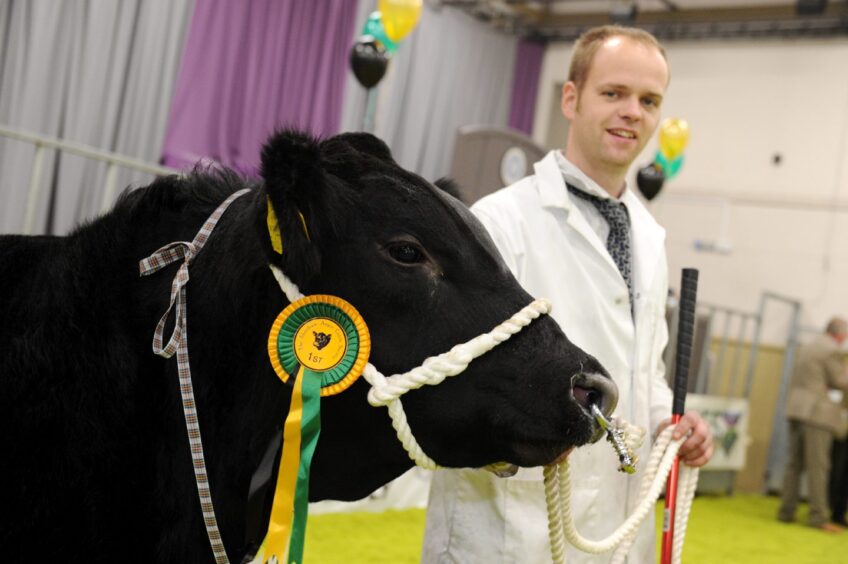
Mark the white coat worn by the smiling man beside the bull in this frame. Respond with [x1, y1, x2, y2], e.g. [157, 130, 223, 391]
[422, 152, 671, 564]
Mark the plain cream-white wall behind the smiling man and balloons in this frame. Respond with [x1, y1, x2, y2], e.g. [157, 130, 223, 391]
[533, 39, 848, 340]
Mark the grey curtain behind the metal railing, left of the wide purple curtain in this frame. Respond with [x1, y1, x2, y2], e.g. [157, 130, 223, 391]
[0, 0, 192, 234]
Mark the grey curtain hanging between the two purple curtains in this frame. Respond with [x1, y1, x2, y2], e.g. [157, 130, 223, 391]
[342, 4, 518, 185]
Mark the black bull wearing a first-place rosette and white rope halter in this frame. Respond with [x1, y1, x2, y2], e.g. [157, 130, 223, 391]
[0, 132, 616, 563]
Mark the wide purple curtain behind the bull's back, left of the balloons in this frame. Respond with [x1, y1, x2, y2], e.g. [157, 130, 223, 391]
[162, 0, 357, 174]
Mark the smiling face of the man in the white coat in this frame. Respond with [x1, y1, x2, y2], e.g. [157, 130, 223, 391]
[562, 37, 668, 187]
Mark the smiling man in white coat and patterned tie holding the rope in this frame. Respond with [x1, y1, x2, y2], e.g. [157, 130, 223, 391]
[422, 26, 713, 564]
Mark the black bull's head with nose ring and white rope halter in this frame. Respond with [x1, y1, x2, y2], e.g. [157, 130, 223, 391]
[256, 132, 617, 499]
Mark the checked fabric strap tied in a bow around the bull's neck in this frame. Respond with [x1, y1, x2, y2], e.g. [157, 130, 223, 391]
[138, 189, 250, 564]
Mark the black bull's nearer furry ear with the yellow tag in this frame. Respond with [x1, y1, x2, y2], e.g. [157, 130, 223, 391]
[256, 130, 327, 286]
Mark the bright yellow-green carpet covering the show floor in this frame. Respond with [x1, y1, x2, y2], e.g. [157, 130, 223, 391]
[304, 495, 848, 564]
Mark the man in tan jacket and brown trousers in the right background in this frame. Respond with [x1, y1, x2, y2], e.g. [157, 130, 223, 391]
[777, 317, 848, 533]
